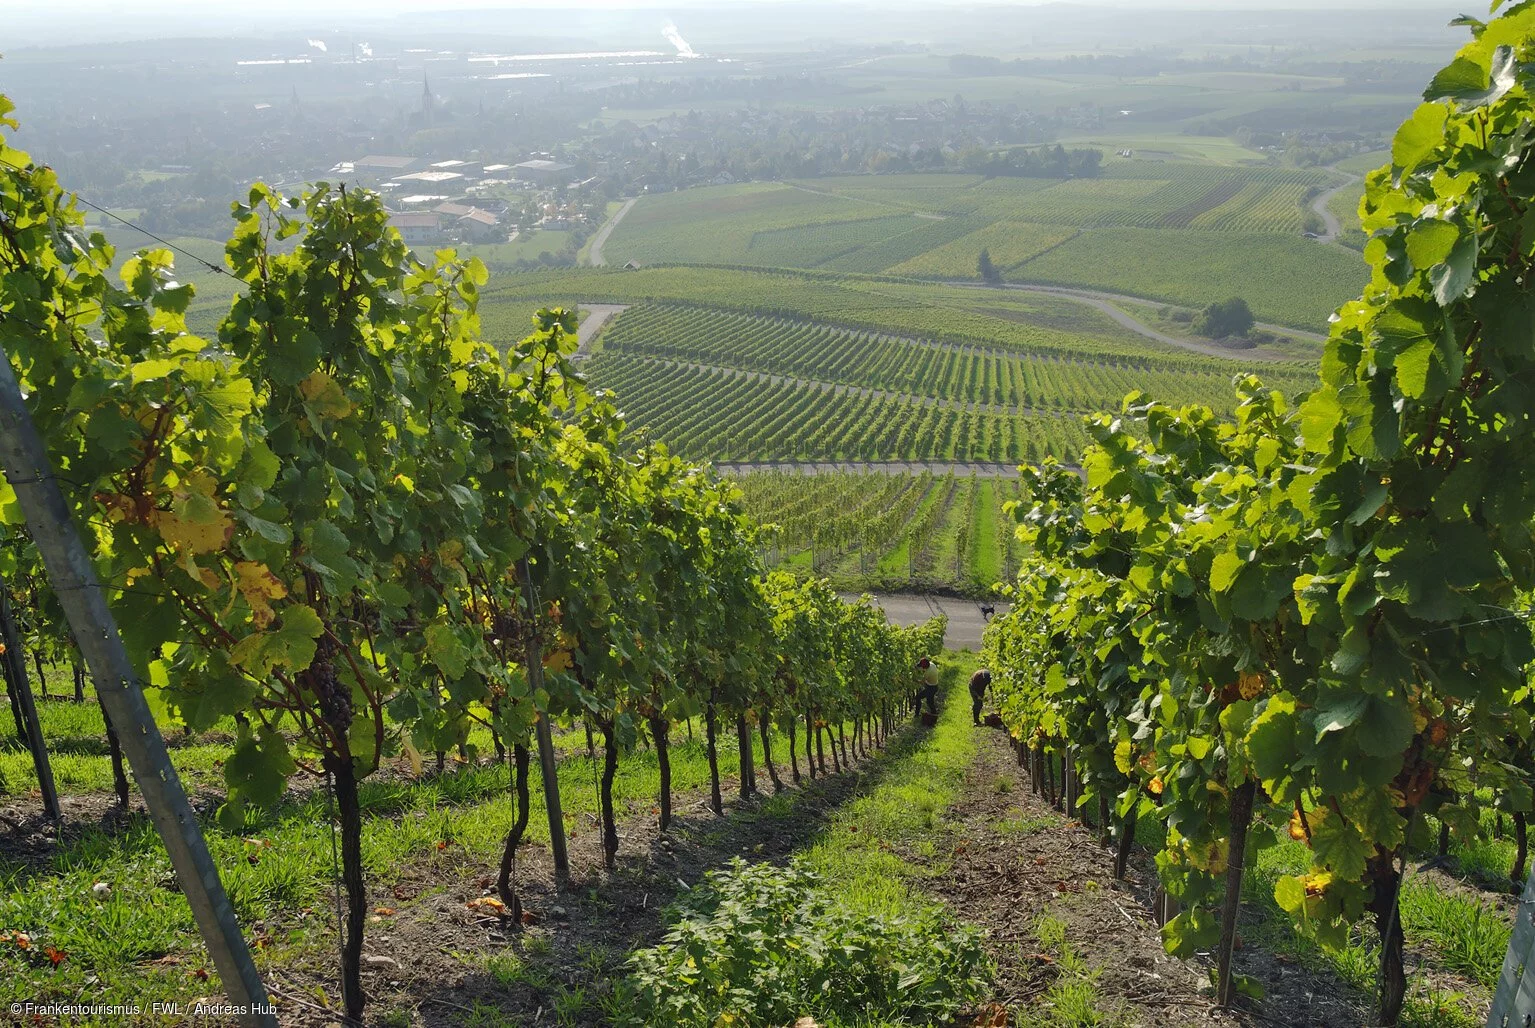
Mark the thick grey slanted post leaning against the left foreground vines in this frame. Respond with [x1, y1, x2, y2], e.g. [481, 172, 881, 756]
[0, 350, 278, 1028]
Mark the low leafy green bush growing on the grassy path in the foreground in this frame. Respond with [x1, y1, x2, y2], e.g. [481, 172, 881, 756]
[620, 859, 990, 1028]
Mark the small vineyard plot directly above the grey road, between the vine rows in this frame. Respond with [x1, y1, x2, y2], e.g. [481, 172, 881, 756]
[735, 471, 1021, 595]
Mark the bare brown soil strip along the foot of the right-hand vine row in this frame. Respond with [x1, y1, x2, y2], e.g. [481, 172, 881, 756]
[932, 729, 1369, 1028]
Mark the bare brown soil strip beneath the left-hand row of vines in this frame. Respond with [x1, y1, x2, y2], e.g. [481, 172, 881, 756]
[261, 727, 929, 1028]
